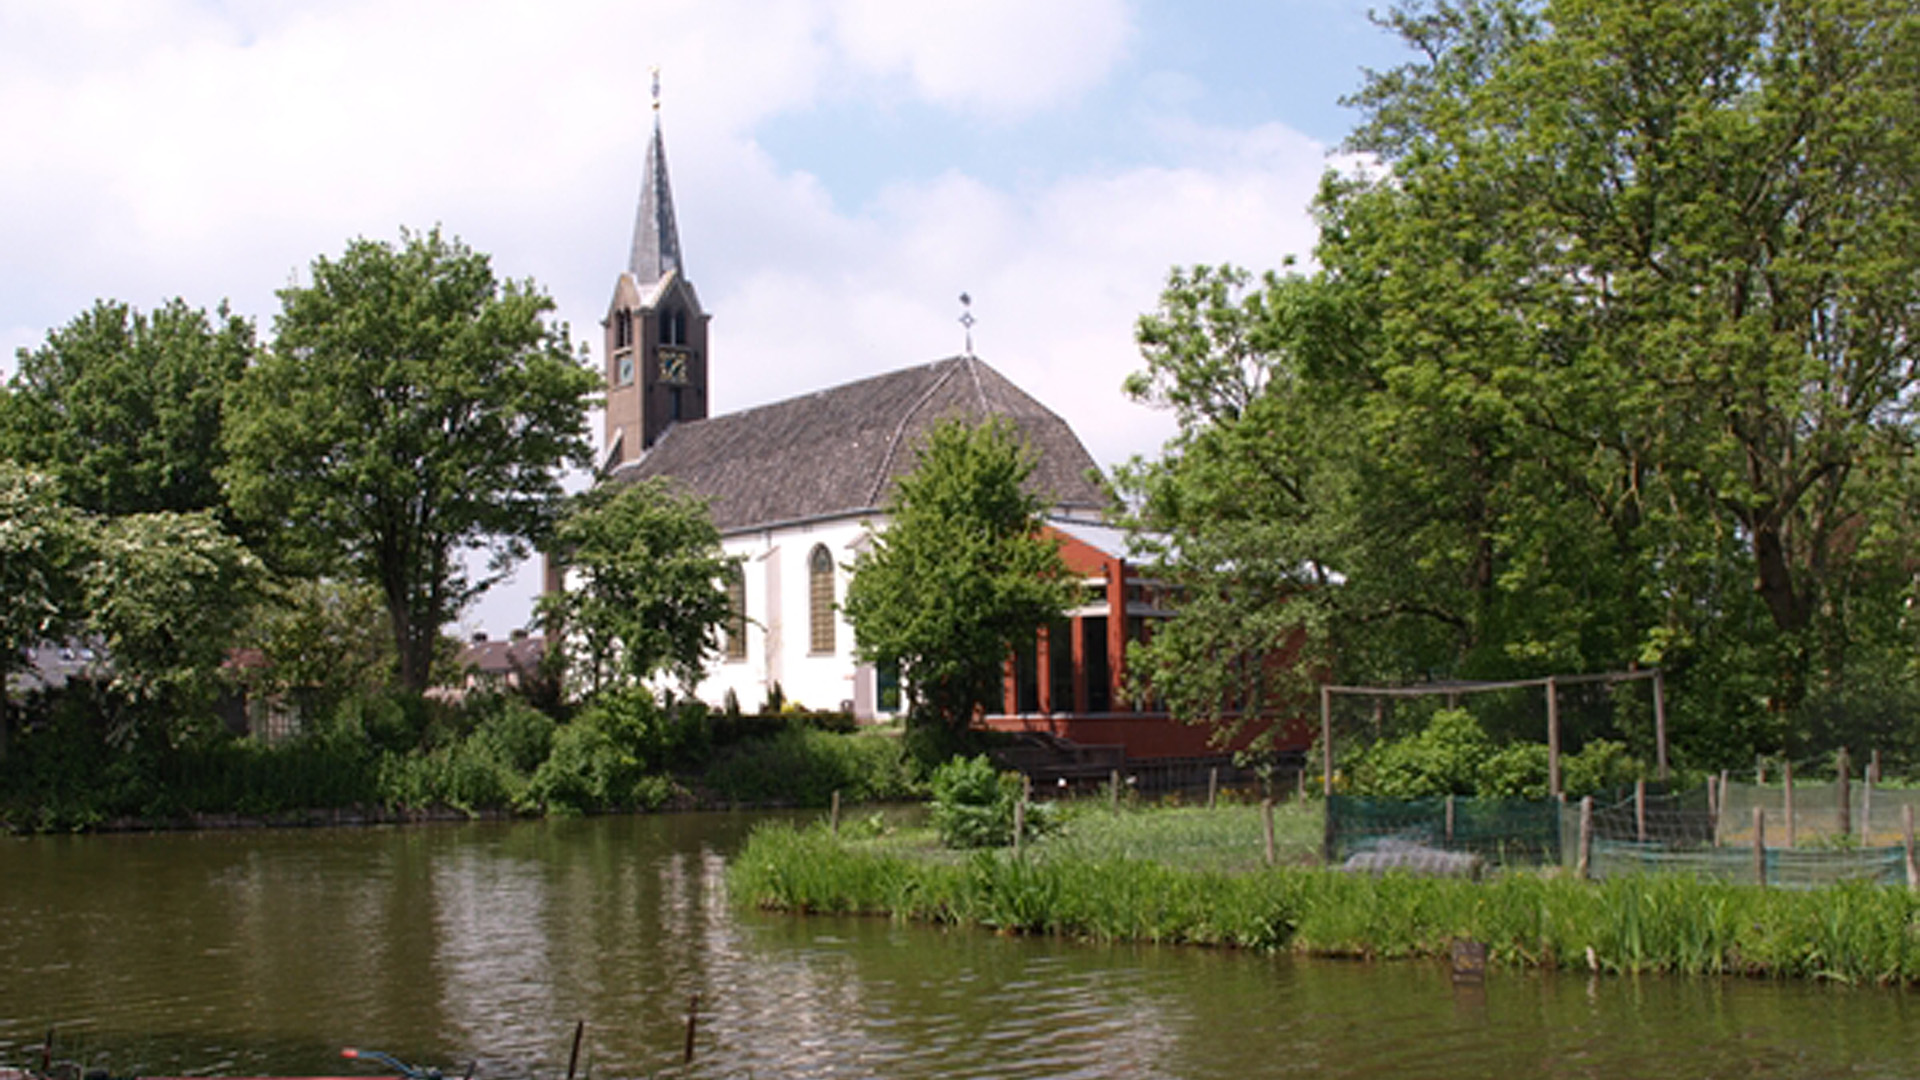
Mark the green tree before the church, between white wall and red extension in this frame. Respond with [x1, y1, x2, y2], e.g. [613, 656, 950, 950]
[845, 419, 1073, 730]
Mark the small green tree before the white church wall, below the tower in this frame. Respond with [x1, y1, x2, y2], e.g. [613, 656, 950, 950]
[541, 480, 735, 694]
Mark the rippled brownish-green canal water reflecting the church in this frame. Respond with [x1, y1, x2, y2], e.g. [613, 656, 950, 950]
[0, 815, 1920, 1080]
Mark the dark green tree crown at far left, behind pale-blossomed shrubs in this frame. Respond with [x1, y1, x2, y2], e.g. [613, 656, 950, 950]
[0, 300, 253, 515]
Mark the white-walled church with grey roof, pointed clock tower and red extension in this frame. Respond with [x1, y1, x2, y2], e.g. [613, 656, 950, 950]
[601, 98, 1267, 757]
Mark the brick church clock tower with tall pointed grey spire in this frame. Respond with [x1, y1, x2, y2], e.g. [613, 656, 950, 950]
[601, 73, 708, 471]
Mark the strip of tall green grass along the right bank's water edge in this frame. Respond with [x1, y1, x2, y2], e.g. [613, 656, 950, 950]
[732, 815, 1920, 984]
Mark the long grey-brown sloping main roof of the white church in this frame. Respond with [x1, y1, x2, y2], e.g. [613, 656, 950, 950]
[614, 356, 1108, 532]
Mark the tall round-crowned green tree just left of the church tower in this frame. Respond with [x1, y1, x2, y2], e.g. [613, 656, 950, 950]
[225, 229, 595, 692]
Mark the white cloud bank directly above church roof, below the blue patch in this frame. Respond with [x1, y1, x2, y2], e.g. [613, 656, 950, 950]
[706, 116, 1325, 465]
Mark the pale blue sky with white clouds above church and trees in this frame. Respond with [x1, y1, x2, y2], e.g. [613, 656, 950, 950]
[0, 0, 1407, 636]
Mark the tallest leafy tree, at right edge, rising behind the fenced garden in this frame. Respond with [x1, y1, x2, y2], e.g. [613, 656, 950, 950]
[1321, 0, 1920, 709]
